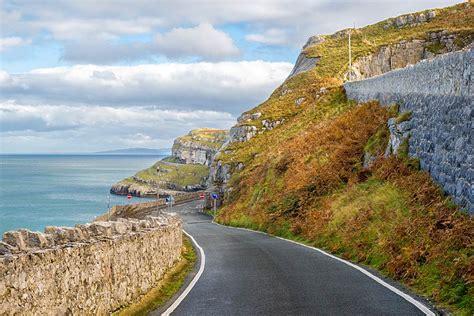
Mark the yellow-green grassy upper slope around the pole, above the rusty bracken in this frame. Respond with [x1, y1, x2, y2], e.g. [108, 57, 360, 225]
[220, 4, 474, 131]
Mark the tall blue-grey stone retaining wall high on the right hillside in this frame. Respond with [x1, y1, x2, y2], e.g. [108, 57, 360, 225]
[344, 47, 474, 214]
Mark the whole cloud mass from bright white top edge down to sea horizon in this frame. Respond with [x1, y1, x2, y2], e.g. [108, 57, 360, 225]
[0, 61, 292, 152]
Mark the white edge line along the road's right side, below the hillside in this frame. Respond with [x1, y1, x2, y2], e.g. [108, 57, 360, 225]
[212, 221, 436, 316]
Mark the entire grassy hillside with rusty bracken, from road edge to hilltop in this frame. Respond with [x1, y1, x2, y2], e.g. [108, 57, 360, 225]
[217, 4, 474, 315]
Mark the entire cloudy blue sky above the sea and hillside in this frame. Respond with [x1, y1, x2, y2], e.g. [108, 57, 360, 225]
[0, 0, 459, 153]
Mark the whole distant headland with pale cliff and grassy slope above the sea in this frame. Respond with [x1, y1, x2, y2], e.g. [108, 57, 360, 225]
[110, 128, 228, 197]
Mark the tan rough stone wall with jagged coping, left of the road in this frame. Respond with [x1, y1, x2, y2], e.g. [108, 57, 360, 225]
[0, 214, 182, 315]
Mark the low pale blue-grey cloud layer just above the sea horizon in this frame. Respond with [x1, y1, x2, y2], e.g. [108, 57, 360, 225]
[0, 101, 235, 152]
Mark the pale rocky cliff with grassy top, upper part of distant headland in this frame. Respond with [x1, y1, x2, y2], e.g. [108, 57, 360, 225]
[172, 128, 228, 166]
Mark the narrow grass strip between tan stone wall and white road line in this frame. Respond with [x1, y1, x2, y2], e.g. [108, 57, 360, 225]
[113, 235, 197, 316]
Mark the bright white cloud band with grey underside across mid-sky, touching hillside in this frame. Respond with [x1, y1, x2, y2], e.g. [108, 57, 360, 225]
[0, 61, 292, 114]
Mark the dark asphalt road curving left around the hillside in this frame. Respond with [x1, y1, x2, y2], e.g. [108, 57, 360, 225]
[159, 201, 434, 316]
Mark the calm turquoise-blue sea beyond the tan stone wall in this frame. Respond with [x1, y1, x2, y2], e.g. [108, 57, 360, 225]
[0, 155, 162, 234]
